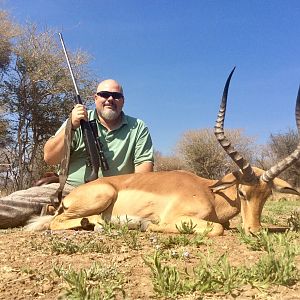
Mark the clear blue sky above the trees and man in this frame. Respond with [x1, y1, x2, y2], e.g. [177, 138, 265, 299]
[0, 0, 300, 154]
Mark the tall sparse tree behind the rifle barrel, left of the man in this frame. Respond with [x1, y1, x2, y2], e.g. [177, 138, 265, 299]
[0, 24, 96, 189]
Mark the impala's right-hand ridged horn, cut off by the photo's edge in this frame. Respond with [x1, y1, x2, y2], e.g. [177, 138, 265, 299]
[261, 86, 300, 182]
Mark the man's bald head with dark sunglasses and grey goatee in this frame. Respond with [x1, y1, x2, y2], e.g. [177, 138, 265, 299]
[94, 79, 124, 122]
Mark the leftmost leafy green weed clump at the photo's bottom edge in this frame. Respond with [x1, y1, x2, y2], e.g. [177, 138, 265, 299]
[54, 263, 125, 300]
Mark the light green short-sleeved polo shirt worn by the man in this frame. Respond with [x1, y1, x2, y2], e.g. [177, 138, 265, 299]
[56, 110, 154, 186]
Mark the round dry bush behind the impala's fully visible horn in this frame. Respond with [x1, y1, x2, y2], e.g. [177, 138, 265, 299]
[176, 129, 254, 179]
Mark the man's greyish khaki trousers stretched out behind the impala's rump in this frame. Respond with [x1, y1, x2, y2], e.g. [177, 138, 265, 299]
[0, 183, 75, 229]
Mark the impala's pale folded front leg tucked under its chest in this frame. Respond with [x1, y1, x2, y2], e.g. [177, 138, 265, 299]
[147, 217, 224, 236]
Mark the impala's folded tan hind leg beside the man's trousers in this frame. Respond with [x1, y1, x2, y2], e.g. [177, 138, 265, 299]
[50, 184, 117, 230]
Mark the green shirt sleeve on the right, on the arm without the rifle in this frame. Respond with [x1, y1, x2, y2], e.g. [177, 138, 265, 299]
[134, 121, 154, 166]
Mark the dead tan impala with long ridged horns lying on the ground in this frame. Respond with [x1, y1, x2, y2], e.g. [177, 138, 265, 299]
[26, 69, 300, 236]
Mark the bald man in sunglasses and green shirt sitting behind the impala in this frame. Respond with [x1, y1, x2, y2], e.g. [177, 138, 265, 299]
[0, 79, 153, 228]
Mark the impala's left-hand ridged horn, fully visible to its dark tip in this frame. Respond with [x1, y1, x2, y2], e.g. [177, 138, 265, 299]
[214, 67, 257, 183]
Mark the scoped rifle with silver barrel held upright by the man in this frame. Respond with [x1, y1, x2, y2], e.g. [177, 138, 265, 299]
[58, 33, 109, 182]
